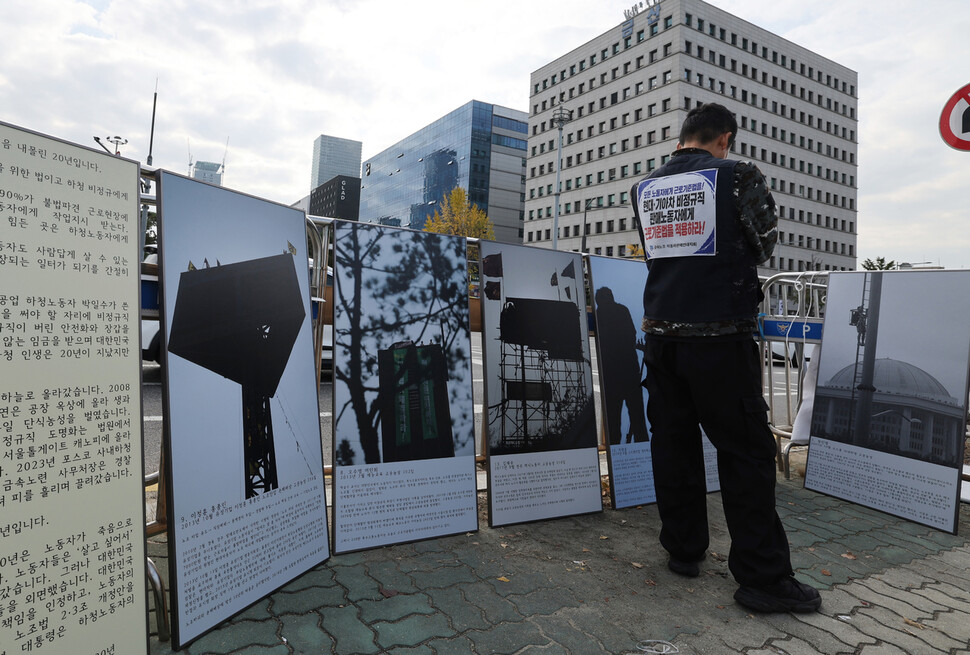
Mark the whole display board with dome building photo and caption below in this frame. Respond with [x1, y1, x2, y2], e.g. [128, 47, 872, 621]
[805, 271, 970, 533]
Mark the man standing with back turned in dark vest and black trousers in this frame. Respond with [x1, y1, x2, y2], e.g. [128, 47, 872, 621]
[633, 103, 822, 612]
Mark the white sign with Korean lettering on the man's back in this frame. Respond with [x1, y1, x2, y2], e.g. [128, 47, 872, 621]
[637, 168, 717, 259]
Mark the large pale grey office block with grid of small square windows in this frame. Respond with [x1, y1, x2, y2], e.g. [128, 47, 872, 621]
[525, 0, 858, 275]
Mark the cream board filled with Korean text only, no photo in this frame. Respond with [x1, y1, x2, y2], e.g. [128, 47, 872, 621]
[0, 123, 148, 655]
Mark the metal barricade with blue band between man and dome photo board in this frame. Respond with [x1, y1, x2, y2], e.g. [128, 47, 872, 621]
[759, 271, 828, 478]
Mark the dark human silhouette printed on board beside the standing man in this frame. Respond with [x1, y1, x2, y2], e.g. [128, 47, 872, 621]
[594, 286, 650, 444]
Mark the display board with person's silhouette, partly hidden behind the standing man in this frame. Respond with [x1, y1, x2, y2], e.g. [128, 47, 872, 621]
[589, 256, 720, 509]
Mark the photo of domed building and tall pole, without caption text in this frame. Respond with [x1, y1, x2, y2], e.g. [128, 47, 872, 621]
[811, 271, 970, 468]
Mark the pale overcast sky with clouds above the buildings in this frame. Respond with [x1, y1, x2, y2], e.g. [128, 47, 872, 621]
[0, 0, 970, 268]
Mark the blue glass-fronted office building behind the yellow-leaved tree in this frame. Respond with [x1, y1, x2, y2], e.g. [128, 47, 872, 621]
[360, 100, 528, 243]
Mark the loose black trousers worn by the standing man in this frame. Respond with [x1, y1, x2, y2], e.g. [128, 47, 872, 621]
[644, 336, 792, 586]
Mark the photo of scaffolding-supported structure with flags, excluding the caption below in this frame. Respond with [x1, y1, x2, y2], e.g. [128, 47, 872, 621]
[480, 242, 597, 456]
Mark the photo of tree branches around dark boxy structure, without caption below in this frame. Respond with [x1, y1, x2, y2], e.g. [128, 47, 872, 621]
[334, 222, 475, 466]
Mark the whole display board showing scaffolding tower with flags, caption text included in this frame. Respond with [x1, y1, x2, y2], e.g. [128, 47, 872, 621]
[479, 241, 603, 526]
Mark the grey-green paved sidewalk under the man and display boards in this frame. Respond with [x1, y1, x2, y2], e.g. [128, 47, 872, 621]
[149, 472, 970, 655]
